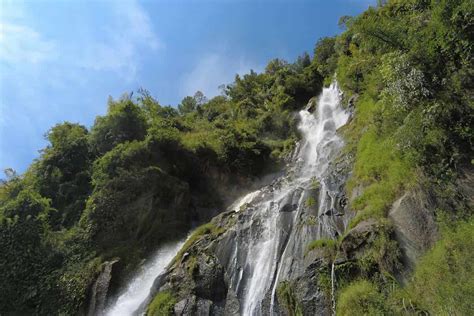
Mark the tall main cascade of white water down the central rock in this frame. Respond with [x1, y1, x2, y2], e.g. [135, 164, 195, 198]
[221, 83, 349, 315]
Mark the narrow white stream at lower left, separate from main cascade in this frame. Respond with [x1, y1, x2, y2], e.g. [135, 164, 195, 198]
[105, 239, 185, 316]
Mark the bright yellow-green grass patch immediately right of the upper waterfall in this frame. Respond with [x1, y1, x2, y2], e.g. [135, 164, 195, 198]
[347, 98, 415, 228]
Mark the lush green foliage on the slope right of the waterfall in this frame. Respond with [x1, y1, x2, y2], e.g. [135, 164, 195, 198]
[330, 0, 474, 315]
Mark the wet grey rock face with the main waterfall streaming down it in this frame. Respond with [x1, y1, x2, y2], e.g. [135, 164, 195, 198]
[146, 82, 353, 315]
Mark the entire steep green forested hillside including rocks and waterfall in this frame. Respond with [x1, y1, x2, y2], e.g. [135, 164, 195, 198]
[0, 0, 474, 315]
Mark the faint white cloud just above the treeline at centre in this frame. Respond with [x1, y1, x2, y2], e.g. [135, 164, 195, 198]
[181, 53, 263, 97]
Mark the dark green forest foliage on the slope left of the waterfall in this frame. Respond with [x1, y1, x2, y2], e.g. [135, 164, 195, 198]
[0, 49, 323, 314]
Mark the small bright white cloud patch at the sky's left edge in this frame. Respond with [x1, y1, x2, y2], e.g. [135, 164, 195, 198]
[0, 22, 56, 64]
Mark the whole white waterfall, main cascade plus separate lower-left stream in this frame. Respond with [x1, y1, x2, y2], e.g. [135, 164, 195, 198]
[124, 82, 352, 316]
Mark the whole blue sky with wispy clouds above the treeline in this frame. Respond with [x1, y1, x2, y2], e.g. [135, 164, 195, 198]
[0, 0, 375, 172]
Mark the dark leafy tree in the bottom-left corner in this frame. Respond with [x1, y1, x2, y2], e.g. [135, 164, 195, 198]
[0, 190, 61, 314]
